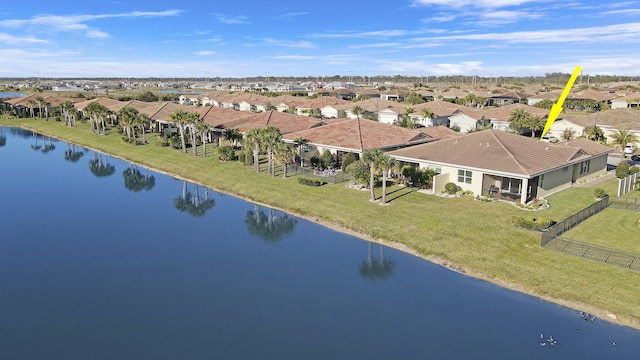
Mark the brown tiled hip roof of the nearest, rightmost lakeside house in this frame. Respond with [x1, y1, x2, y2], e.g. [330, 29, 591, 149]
[389, 130, 612, 178]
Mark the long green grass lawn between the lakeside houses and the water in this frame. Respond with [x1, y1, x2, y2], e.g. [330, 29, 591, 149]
[0, 114, 640, 327]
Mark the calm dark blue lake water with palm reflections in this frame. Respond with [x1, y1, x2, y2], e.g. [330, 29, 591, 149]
[0, 128, 640, 359]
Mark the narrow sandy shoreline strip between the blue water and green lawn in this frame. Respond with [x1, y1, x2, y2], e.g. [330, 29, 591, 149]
[12, 126, 640, 330]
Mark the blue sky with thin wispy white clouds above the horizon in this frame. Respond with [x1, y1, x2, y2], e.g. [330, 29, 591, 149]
[0, 0, 640, 77]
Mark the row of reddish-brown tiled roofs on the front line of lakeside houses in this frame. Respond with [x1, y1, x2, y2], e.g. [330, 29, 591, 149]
[2, 93, 616, 176]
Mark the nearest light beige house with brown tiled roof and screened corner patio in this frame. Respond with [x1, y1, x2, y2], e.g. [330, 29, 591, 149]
[389, 130, 612, 203]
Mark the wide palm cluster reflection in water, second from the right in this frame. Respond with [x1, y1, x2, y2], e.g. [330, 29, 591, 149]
[244, 205, 297, 242]
